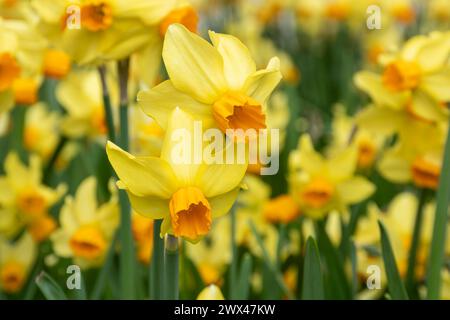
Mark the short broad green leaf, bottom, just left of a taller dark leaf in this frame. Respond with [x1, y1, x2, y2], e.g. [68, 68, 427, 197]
[302, 237, 325, 300]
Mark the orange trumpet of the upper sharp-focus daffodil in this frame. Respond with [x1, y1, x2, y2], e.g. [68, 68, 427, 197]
[213, 92, 266, 132]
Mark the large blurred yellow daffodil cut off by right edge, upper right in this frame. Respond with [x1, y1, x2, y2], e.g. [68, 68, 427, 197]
[355, 32, 450, 122]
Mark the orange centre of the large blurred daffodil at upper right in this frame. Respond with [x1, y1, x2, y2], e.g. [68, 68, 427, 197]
[382, 60, 422, 91]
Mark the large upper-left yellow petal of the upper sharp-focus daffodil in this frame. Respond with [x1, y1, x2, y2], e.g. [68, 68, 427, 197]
[163, 24, 226, 104]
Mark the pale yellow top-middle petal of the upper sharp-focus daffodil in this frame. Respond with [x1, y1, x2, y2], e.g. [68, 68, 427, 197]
[209, 31, 256, 90]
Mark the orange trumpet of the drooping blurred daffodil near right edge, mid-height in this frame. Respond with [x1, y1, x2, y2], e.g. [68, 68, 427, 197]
[411, 157, 441, 190]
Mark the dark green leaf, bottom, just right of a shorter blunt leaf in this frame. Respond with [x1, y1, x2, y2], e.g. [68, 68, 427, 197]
[317, 221, 352, 300]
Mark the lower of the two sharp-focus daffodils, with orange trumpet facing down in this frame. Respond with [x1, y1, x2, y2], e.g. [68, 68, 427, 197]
[106, 108, 247, 241]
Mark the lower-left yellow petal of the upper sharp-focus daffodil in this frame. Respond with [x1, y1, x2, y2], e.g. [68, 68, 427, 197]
[137, 80, 214, 129]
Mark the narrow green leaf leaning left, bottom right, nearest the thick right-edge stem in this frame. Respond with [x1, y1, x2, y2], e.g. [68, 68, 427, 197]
[378, 221, 408, 300]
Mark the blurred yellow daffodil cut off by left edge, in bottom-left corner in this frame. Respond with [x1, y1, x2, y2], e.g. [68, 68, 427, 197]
[0, 232, 37, 293]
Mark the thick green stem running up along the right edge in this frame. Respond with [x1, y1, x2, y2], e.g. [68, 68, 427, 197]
[427, 128, 450, 299]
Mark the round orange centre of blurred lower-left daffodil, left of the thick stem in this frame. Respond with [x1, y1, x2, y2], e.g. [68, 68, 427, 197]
[69, 226, 107, 260]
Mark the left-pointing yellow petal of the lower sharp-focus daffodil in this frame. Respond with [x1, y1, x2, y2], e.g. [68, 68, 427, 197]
[106, 142, 177, 199]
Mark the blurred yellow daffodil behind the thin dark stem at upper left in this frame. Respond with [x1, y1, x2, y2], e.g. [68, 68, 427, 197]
[56, 71, 118, 138]
